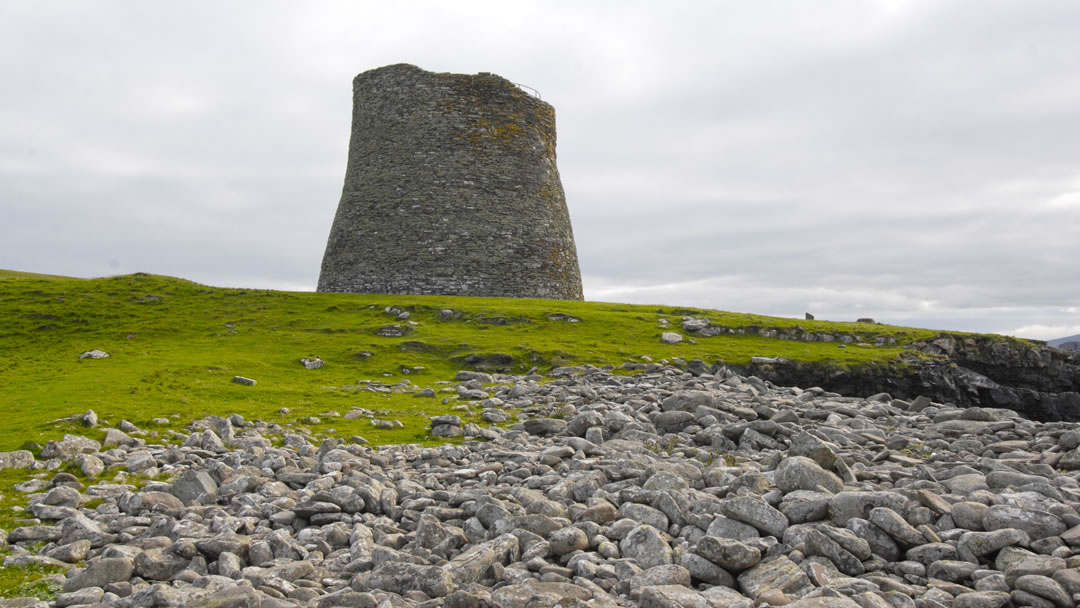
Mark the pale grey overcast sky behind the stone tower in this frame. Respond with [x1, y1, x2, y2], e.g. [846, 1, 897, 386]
[0, 0, 1080, 339]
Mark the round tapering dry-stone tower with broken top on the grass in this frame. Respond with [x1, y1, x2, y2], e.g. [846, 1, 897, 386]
[319, 64, 582, 299]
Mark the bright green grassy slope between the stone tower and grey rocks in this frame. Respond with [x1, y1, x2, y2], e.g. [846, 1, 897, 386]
[0, 271, 959, 450]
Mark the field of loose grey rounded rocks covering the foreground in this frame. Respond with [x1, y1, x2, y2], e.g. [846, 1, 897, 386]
[0, 364, 1080, 608]
